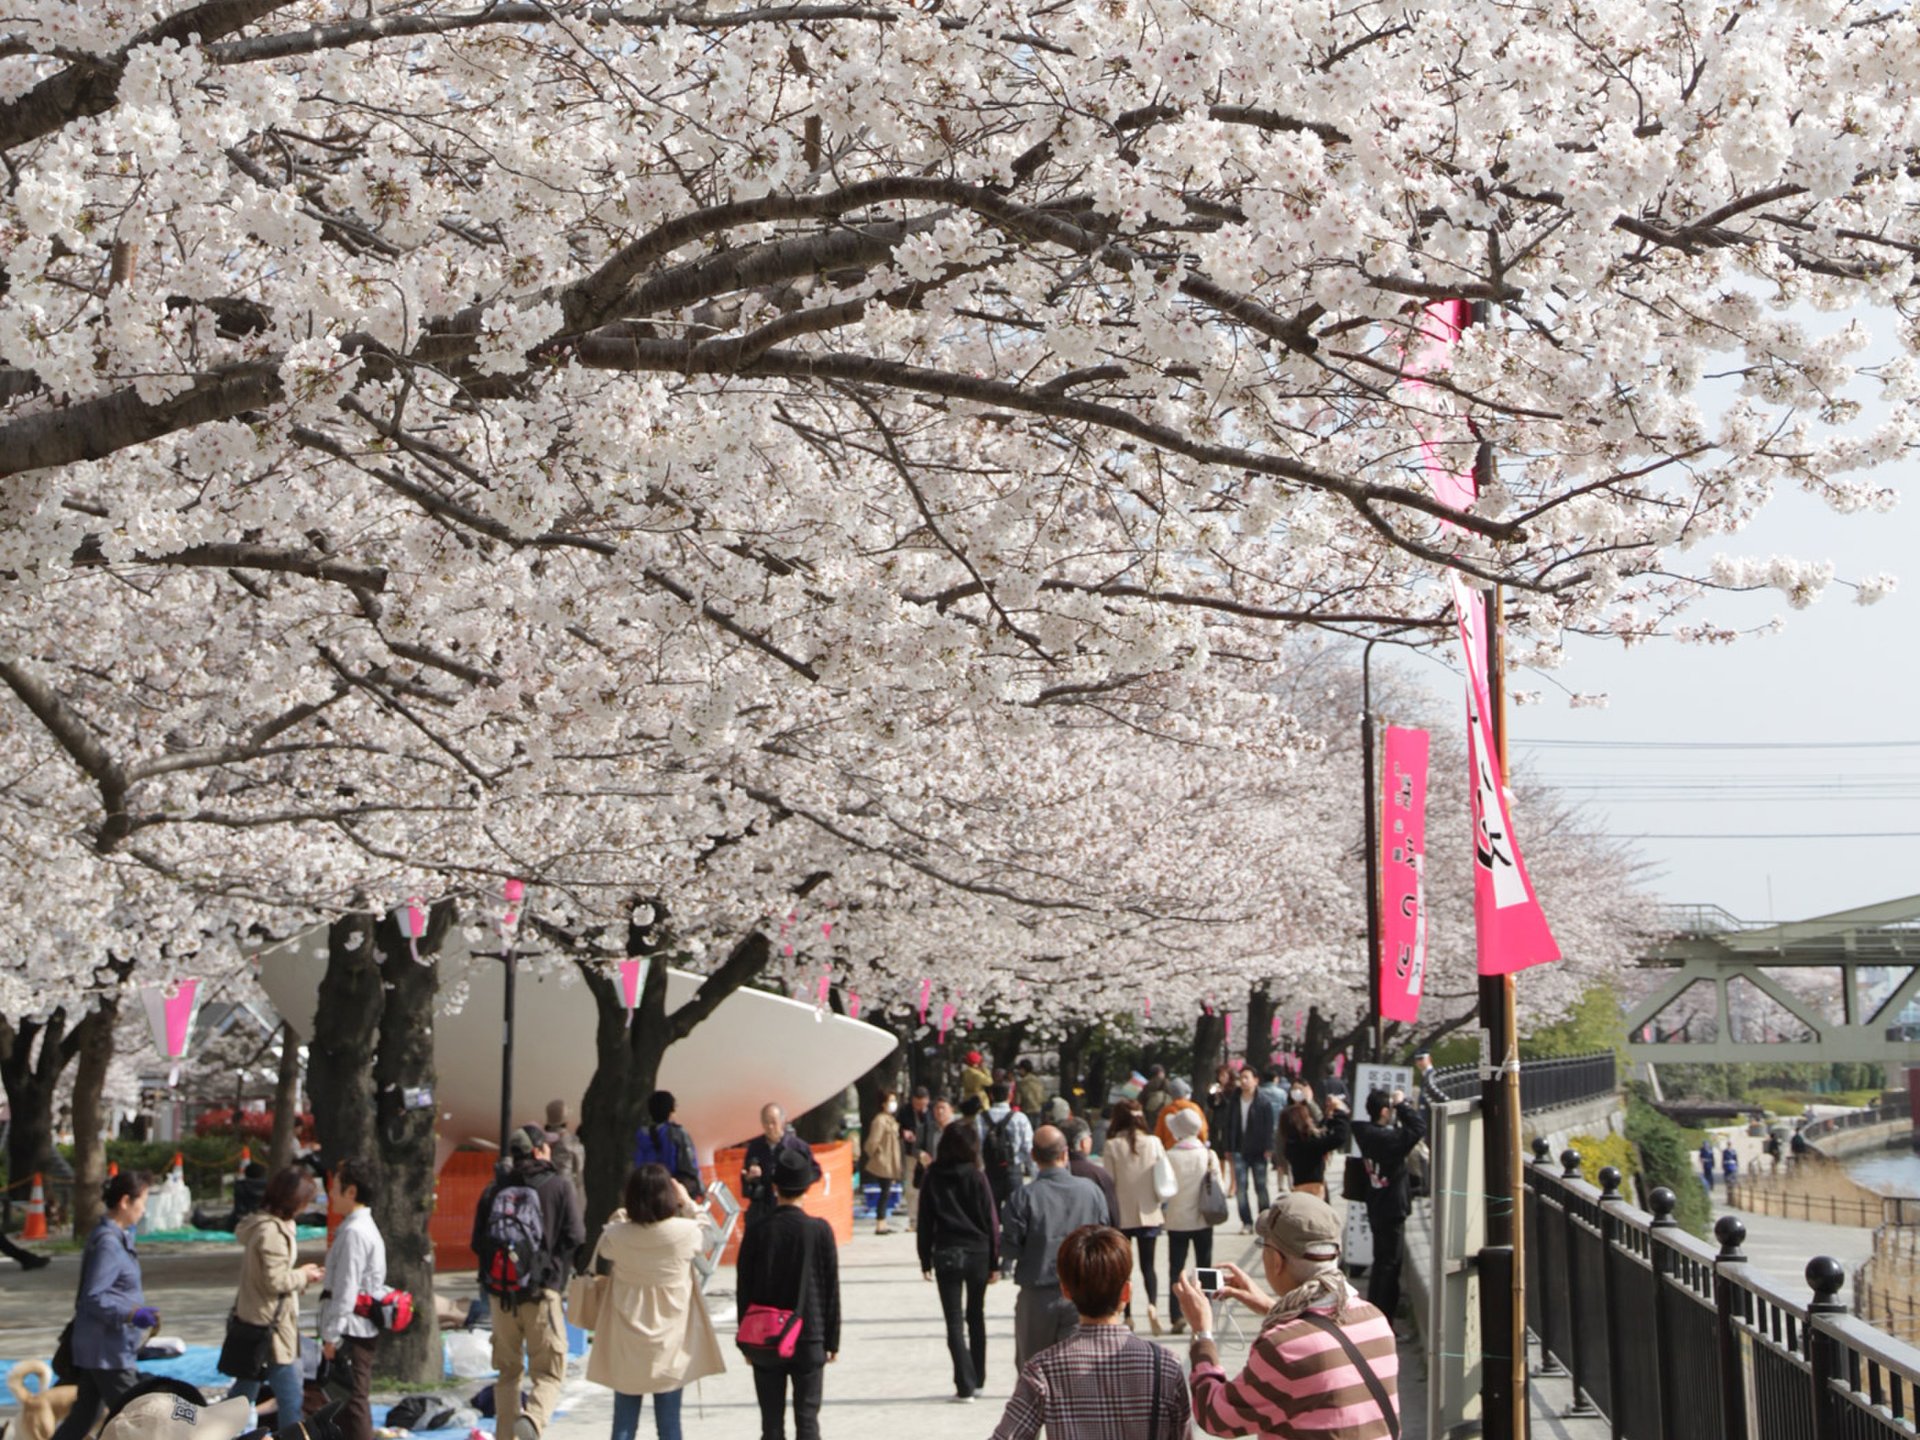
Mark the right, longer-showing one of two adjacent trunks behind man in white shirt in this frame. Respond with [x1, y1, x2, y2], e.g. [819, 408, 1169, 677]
[372, 900, 445, 1384]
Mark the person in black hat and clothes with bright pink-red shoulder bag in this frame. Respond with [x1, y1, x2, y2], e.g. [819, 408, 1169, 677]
[733, 1146, 839, 1440]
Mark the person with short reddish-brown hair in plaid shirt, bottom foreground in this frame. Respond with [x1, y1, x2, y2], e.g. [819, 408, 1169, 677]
[993, 1225, 1192, 1440]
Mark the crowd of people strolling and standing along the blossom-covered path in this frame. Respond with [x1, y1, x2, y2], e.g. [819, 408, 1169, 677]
[26, 1054, 1425, 1440]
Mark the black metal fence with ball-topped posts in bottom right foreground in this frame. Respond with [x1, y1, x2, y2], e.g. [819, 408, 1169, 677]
[1524, 1140, 1920, 1440]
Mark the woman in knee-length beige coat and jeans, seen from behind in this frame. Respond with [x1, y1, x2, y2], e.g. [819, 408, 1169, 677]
[588, 1165, 726, 1440]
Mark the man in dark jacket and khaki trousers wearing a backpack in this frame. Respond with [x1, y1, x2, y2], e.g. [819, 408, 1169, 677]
[472, 1125, 588, 1440]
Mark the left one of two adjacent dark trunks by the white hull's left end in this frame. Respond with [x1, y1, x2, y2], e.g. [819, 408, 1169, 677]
[307, 916, 384, 1169]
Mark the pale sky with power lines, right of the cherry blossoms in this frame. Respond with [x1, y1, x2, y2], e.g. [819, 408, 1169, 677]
[1402, 311, 1920, 920]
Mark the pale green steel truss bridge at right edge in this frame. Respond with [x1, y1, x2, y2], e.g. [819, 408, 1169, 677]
[1626, 895, 1920, 1069]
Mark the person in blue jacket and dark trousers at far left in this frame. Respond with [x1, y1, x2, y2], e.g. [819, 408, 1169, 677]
[54, 1171, 159, 1440]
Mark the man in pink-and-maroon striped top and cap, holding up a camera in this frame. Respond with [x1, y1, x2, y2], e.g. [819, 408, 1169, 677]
[1173, 1190, 1400, 1440]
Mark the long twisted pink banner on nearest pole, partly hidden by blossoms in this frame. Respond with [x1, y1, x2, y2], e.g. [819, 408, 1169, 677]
[1405, 300, 1561, 975]
